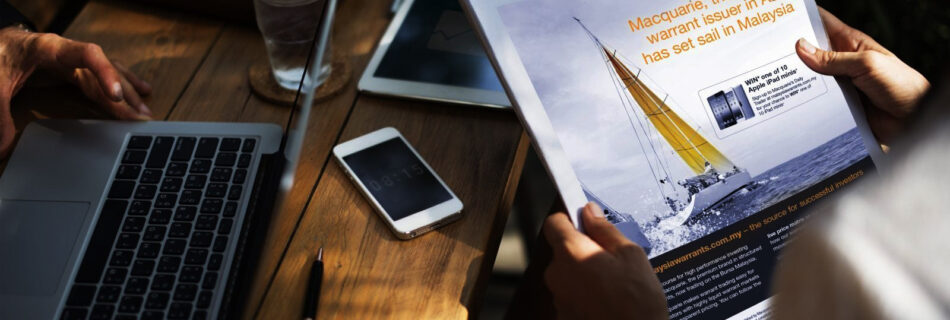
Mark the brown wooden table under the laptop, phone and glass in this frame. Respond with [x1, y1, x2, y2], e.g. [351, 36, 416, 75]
[5, 0, 528, 319]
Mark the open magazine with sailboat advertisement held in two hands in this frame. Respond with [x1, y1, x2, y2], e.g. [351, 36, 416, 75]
[462, 0, 881, 319]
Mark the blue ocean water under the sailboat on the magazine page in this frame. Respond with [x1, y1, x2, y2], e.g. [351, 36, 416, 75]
[643, 129, 868, 257]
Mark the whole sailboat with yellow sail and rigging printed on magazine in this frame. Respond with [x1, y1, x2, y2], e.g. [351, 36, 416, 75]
[574, 18, 753, 229]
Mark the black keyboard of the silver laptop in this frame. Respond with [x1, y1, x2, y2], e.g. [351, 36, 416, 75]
[62, 135, 257, 319]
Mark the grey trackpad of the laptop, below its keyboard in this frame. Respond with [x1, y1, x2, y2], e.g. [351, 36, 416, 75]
[0, 200, 89, 296]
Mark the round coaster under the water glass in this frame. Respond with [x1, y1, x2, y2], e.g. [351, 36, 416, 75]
[247, 52, 351, 106]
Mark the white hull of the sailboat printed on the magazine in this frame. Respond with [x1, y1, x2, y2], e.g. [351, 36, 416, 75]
[664, 170, 752, 226]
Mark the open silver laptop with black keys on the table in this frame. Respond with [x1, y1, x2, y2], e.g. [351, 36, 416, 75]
[0, 0, 336, 319]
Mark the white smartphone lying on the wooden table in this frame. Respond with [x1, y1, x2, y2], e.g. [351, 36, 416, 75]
[333, 128, 462, 240]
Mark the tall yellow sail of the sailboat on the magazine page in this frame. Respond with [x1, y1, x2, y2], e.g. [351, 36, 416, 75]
[603, 47, 734, 174]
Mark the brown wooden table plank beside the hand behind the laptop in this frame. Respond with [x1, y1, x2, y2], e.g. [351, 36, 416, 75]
[13, 1, 221, 129]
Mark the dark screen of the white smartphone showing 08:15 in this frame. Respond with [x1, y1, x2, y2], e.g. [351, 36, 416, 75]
[343, 137, 452, 221]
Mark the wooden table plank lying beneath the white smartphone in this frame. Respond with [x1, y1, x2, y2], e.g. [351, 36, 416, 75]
[258, 96, 527, 319]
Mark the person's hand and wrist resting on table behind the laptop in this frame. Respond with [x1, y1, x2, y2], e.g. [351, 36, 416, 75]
[0, 2, 152, 158]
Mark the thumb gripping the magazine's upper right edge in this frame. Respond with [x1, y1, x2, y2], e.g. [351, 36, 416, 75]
[795, 38, 881, 78]
